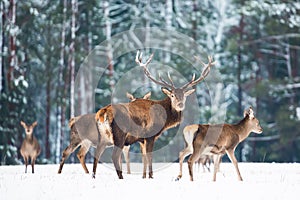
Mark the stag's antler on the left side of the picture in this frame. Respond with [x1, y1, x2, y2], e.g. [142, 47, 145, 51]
[135, 51, 174, 89]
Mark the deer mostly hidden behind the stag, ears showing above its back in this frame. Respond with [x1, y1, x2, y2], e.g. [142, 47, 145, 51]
[58, 92, 151, 174]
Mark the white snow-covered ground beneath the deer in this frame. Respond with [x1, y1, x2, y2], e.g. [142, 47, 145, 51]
[0, 163, 300, 200]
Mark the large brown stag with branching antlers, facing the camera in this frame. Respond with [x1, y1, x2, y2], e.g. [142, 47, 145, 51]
[93, 51, 214, 179]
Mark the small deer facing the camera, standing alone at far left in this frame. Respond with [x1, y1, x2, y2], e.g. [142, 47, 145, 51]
[20, 121, 41, 173]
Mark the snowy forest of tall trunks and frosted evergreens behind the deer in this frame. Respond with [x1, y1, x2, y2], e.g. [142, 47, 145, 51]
[0, 0, 300, 165]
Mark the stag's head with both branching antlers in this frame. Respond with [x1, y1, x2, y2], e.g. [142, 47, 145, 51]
[135, 51, 215, 112]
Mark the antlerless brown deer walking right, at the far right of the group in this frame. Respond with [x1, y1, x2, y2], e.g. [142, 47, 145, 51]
[178, 107, 263, 181]
